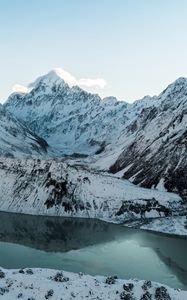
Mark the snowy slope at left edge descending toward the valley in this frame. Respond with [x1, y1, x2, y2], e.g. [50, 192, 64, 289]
[0, 106, 47, 157]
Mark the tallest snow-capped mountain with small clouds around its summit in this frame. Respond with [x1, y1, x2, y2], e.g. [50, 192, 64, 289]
[5, 70, 152, 154]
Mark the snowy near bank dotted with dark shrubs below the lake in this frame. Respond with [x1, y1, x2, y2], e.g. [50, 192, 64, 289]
[0, 269, 187, 300]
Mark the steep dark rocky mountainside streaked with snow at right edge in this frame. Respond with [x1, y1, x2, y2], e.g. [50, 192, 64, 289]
[110, 78, 187, 199]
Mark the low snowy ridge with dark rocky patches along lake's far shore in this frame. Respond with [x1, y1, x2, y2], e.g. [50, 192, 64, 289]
[0, 159, 186, 222]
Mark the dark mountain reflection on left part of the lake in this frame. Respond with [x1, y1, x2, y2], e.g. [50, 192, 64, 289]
[0, 212, 124, 252]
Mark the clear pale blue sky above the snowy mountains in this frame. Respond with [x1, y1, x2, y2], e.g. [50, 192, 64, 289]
[0, 0, 187, 102]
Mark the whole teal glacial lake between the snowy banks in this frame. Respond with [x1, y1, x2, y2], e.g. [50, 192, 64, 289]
[0, 212, 187, 289]
